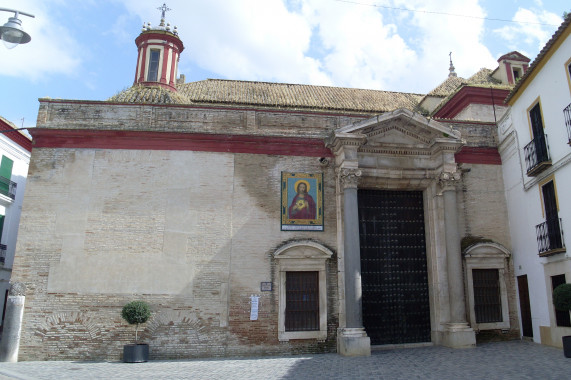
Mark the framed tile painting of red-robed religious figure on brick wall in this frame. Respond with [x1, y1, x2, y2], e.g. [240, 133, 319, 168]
[281, 172, 323, 231]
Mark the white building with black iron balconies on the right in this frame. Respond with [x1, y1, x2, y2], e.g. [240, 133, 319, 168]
[498, 17, 571, 347]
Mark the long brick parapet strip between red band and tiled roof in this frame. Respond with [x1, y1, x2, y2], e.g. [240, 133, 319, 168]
[37, 99, 368, 138]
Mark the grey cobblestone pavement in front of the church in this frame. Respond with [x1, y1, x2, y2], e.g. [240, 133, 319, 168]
[0, 341, 571, 380]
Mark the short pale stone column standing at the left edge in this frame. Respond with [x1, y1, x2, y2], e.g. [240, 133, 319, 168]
[0, 282, 26, 362]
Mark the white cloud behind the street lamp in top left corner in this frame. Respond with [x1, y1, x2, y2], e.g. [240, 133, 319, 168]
[0, 0, 81, 81]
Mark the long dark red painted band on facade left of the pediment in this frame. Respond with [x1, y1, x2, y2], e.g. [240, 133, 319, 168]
[31, 128, 333, 157]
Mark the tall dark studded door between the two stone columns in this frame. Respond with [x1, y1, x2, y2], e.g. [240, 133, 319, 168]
[358, 190, 430, 345]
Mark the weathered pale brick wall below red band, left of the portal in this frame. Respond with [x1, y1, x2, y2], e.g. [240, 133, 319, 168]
[13, 149, 338, 360]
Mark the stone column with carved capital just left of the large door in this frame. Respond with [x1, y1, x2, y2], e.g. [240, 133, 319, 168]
[338, 168, 371, 356]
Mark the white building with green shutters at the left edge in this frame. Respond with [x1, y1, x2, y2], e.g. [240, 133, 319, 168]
[0, 117, 32, 332]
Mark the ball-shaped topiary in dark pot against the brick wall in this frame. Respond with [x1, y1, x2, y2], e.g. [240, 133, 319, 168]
[121, 301, 151, 363]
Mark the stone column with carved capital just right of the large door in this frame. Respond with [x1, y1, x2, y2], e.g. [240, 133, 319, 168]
[438, 171, 476, 348]
